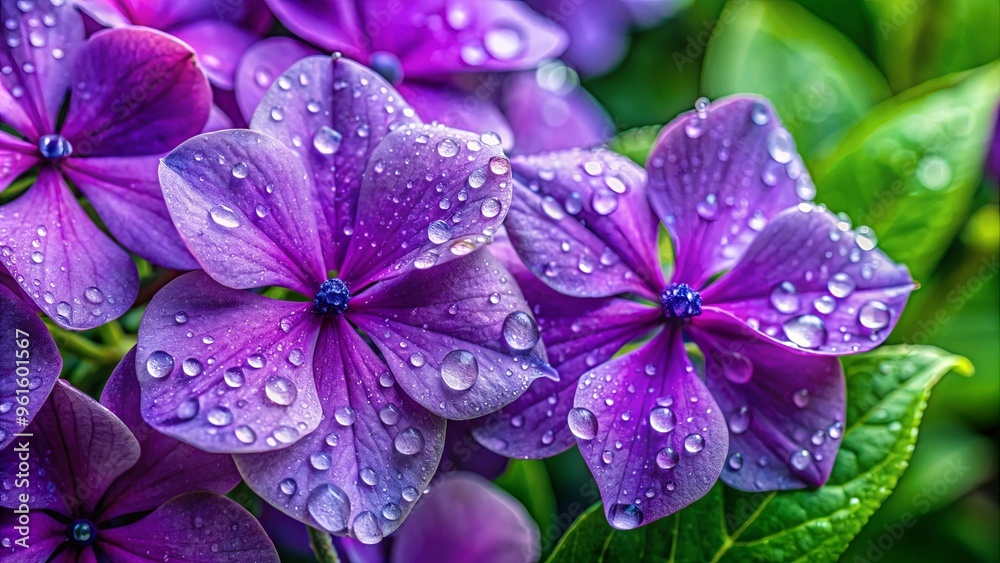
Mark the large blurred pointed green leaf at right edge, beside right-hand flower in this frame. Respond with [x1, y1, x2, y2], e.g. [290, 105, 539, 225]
[810, 63, 1000, 280]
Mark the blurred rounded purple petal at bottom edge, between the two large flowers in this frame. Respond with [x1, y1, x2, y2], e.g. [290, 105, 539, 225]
[391, 473, 541, 563]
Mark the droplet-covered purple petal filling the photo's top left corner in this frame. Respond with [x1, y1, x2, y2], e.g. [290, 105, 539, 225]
[0, 0, 83, 139]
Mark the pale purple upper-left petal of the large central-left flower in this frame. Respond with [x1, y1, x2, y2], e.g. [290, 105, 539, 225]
[160, 130, 326, 295]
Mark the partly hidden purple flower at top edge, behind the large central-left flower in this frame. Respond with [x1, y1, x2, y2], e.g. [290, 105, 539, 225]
[230, 0, 567, 148]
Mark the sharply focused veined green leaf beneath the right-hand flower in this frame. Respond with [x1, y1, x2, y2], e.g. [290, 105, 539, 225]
[548, 346, 972, 563]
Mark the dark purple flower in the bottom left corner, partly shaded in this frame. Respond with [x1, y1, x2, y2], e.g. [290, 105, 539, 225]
[0, 351, 277, 562]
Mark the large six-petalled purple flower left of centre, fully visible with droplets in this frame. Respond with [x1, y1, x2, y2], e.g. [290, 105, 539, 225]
[138, 56, 551, 543]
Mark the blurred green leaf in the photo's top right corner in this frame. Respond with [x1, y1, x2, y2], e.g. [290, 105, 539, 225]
[868, 0, 1000, 92]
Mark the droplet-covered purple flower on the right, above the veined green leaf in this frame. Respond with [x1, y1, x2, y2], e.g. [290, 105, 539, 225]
[476, 96, 914, 528]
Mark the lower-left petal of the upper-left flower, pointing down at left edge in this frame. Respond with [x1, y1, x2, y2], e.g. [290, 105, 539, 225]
[0, 167, 139, 330]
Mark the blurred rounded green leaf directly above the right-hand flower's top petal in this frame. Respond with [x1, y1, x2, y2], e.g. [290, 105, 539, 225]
[701, 0, 890, 155]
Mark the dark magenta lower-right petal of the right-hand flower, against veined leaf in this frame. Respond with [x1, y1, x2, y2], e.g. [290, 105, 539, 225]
[691, 308, 846, 491]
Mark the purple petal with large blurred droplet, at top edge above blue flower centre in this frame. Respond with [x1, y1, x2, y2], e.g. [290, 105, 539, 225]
[374, 0, 567, 78]
